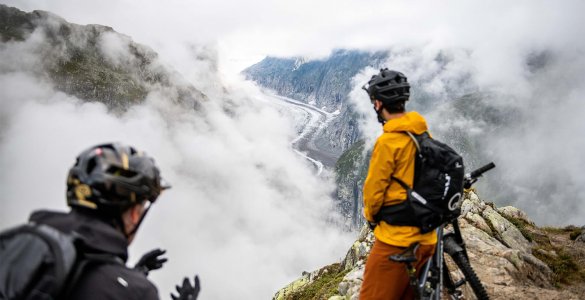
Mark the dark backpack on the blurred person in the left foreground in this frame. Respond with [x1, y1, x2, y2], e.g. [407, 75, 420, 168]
[0, 223, 123, 300]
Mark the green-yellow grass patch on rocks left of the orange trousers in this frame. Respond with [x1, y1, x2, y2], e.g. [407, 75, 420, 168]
[284, 263, 349, 300]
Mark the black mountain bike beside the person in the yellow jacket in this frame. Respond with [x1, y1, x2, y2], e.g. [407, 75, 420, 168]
[389, 163, 495, 300]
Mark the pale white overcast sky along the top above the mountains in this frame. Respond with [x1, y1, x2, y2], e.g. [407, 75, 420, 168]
[0, 0, 585, 71]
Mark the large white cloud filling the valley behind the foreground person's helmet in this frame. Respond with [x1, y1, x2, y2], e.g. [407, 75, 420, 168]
[0, 27, 352, 299]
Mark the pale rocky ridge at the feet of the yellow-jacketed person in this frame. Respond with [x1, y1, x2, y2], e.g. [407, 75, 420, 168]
[274, 191, 585, 300]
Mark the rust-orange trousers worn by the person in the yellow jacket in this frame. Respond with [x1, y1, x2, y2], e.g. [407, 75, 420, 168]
[360, 239, 435, 300]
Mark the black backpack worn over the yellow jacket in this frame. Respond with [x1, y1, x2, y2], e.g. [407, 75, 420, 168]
[375, 132, 465, 233]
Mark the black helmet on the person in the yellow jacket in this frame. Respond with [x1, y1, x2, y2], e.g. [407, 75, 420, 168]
[362, 68, 410, 105]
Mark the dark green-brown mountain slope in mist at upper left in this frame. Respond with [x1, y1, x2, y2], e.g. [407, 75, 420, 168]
[0, 5, 205, 112]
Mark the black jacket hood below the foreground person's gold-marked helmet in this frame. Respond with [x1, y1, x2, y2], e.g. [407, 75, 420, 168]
[29, 210, 128, 262]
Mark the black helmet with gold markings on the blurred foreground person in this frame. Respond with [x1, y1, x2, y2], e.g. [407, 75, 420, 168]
[67, 143, 169, 215]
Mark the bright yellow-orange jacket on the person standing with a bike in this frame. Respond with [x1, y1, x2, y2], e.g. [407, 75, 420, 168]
[364, 112, 437, 247]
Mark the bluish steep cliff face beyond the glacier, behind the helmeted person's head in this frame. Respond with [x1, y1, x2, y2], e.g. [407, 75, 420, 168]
[243, 50, 388, 156]
